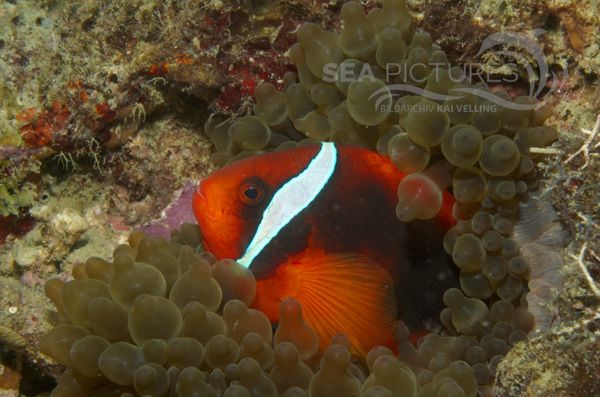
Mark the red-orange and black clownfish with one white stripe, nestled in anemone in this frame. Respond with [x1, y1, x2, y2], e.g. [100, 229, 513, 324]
[193, 142, 458, 355]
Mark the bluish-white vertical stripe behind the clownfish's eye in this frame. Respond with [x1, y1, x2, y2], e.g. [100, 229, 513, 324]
[237, 142, 337, 267]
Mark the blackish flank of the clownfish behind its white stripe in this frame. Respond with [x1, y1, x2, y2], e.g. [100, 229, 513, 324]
[244, 145, 459, 329]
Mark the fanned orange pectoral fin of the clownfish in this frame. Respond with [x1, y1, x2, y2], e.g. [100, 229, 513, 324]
[295, 254, 397, 356]
